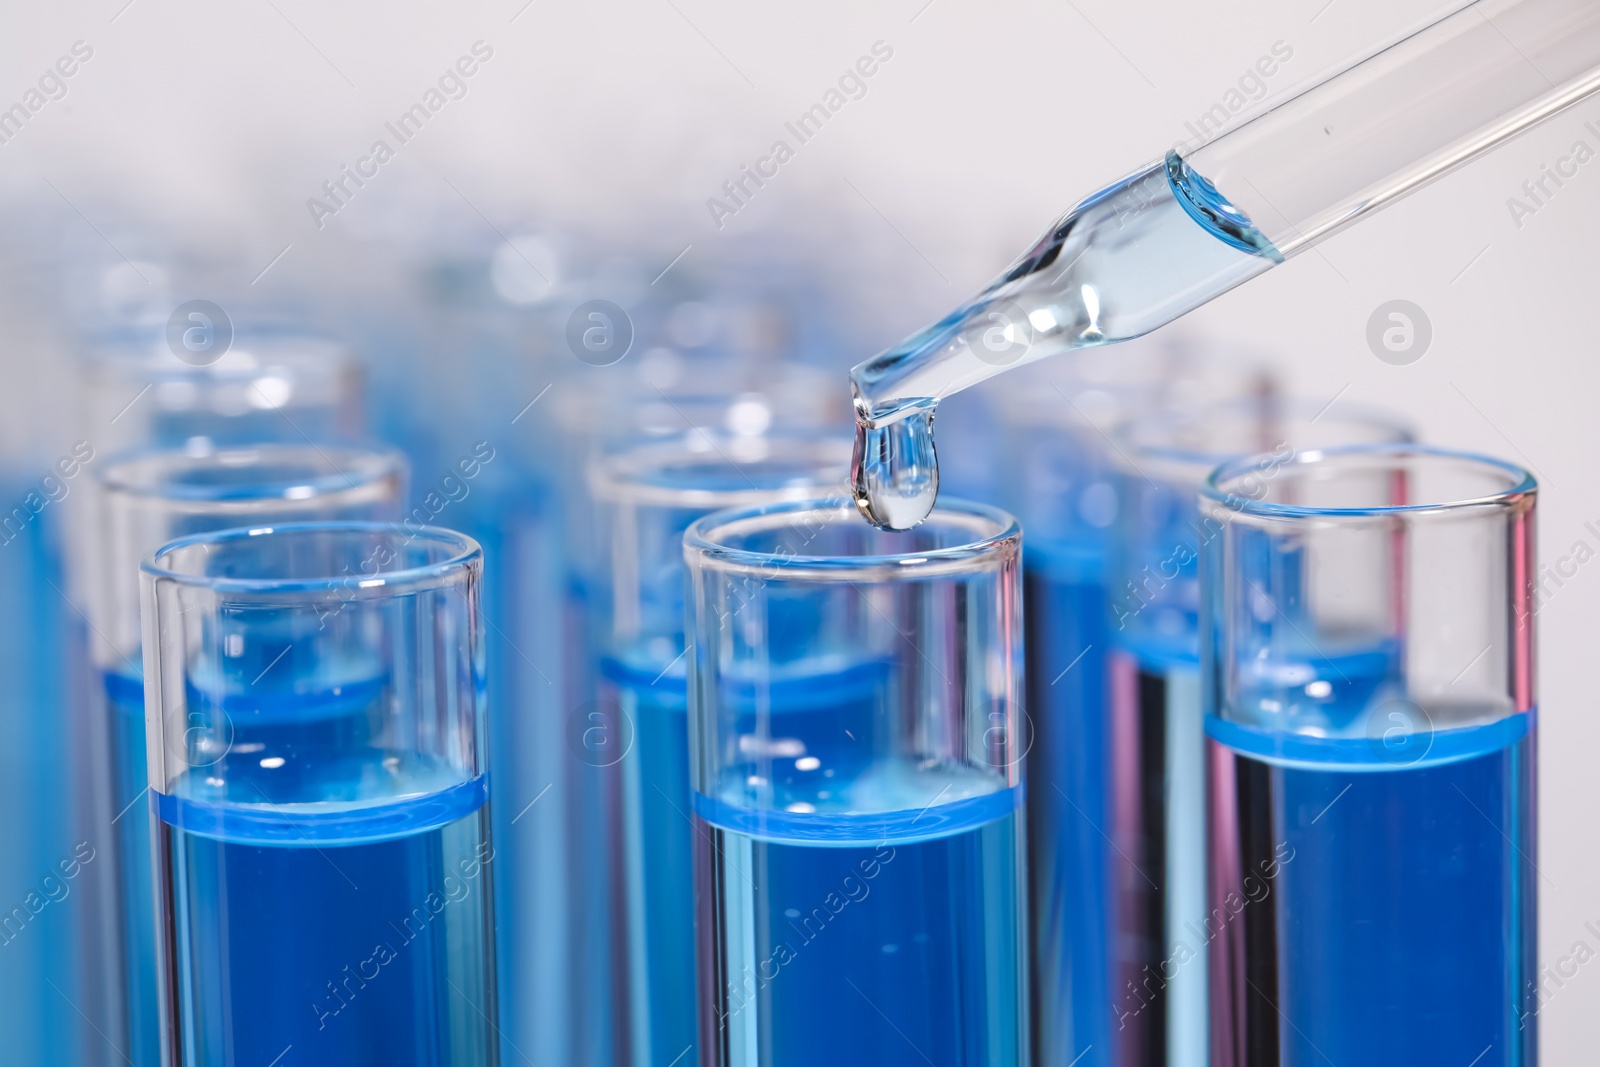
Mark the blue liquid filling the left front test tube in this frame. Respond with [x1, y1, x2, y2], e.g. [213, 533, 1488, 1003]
[152, 662, 499, 1067]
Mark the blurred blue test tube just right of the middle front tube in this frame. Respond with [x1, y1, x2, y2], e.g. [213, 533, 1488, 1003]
[985, 338, 1275, 1067]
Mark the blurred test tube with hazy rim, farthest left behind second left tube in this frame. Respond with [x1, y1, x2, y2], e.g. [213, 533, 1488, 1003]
[70, 334, 362, 1067]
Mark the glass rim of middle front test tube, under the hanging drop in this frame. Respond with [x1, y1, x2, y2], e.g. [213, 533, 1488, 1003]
[683, 498, 1022, 584]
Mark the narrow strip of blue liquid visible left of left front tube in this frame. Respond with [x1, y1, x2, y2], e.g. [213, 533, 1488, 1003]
[104, 672, 162, 1067]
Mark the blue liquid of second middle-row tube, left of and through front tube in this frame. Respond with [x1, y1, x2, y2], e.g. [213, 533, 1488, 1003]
[602, 656, 883, 1067]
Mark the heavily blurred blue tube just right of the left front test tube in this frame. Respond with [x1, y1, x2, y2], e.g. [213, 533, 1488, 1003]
[362, 299, 588, 1067]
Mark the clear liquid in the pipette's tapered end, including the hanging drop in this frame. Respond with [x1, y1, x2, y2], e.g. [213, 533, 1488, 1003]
[851, 154, 1282, 530]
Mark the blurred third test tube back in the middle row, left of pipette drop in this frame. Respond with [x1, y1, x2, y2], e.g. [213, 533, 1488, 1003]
[524, 369, 848, 1067]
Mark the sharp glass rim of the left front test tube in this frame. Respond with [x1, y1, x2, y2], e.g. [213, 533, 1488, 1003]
[139, 520, 483, 600]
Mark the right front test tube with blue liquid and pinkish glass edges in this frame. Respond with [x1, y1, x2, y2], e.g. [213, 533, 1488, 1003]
[1197, 445, 1539, 1067]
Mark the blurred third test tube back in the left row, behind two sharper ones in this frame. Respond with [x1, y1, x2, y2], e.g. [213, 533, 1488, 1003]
[62, 320, 380, 1062]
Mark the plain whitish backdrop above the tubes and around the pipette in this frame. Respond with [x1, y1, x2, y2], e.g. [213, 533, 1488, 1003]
[0, 0, 1600, 1067]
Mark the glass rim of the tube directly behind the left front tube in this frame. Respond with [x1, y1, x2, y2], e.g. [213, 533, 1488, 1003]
[96, 442, 408, 507]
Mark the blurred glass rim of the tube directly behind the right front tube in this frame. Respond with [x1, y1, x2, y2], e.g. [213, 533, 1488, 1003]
[1112, 395, 1416, 485]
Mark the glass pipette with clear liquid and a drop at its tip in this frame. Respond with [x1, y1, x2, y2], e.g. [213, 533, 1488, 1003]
[851, 0, 1600, 530]
